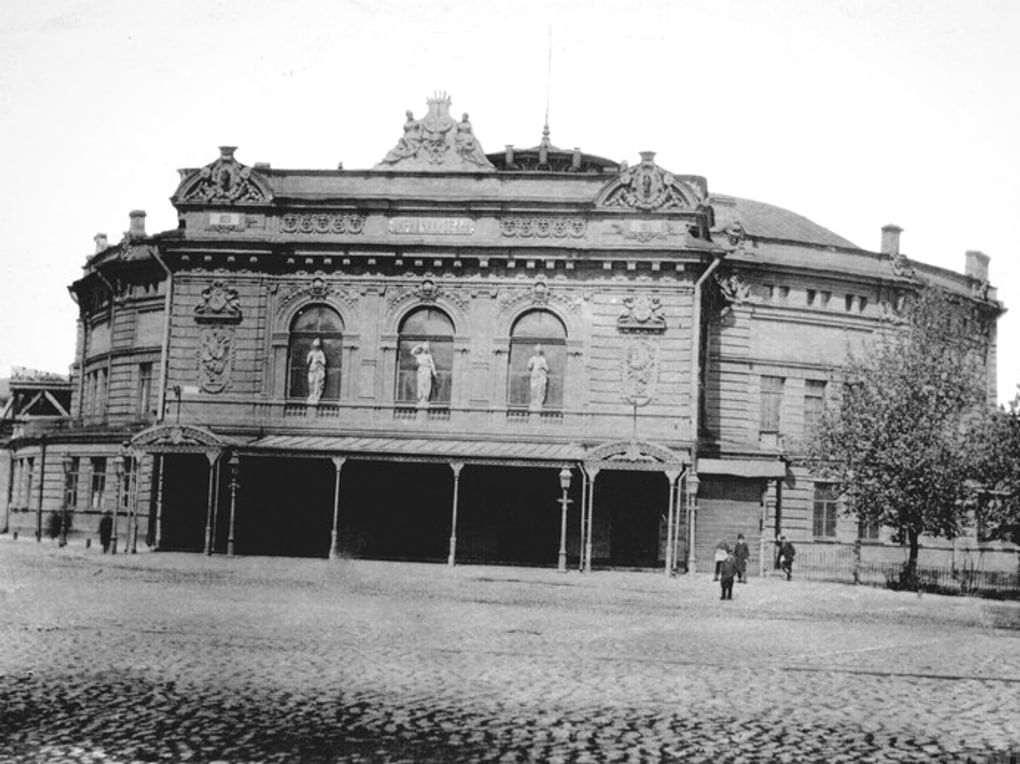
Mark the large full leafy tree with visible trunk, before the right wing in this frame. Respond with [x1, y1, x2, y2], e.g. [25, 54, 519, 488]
[807, 287, 987, 585]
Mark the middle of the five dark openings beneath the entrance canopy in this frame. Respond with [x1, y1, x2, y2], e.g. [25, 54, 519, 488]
[329, 459, 453, 561]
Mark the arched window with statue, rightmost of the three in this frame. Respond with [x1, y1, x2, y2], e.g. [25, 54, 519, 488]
[509, 310, 567, 410]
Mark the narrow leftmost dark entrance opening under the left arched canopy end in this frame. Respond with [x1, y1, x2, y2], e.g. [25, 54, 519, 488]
[159, 454, 209, 552]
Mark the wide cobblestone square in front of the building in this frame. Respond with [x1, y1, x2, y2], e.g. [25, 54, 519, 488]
[0, 541, 1020, 763]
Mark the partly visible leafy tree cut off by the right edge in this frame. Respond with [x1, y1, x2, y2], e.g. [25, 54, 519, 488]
[970, 386, 1020, 544]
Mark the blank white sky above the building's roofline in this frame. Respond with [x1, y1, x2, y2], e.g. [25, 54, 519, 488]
[0, 0, 1020, 401]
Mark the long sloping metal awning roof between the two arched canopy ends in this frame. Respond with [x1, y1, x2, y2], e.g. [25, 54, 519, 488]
[242, 436, 584, 467]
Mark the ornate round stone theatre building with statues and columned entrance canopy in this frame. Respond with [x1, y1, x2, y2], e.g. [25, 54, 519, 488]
[6, 94, 1001, 570]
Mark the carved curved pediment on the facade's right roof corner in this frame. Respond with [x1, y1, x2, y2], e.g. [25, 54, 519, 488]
[595, 151, 707, 212]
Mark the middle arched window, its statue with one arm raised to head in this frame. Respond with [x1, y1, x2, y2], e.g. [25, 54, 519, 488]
[397, 308, 453, 404]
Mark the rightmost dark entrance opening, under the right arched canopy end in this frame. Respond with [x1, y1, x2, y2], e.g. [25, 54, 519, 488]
[593, 470, 669, 567]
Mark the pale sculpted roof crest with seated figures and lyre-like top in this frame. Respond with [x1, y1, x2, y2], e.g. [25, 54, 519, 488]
[375, 93, 496, 172]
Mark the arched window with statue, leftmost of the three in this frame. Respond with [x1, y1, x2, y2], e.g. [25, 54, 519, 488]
[287, 305, 344, 403]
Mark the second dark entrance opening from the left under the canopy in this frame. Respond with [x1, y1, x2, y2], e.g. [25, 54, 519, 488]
[235, 457, 336, 557]
